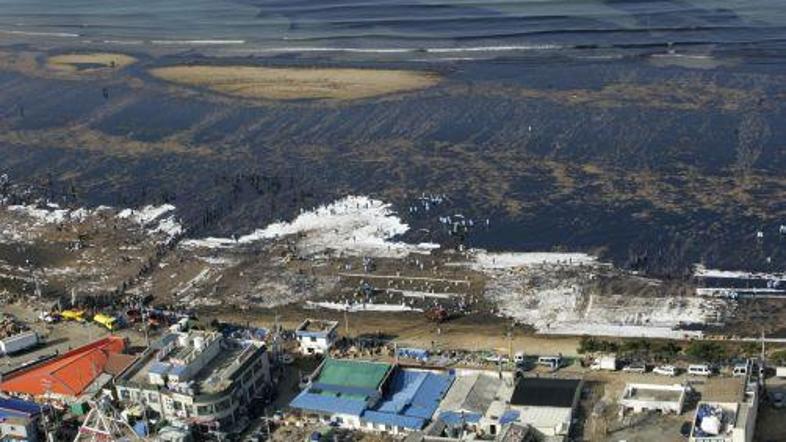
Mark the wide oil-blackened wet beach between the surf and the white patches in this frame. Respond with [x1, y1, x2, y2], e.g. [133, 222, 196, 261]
[0, 48, 786, 276]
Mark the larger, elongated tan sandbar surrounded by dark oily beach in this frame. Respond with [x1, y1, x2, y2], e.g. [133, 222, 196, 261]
[150, 66, 440, 100]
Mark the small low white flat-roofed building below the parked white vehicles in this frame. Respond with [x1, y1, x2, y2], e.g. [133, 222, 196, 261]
[620, 384, 687, 414]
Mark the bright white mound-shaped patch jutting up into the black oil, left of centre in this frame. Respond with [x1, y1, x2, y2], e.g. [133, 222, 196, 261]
[183, 196, 439, 258]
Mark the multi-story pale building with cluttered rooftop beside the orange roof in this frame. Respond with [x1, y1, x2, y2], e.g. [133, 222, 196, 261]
[115, 331, 270, 431]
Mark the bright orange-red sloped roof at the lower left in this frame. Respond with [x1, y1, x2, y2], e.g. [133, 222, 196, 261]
[0, 336, 126, 397]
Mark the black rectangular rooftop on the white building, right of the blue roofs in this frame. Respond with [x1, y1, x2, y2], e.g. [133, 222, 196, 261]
[510, 378, 581, 408]
